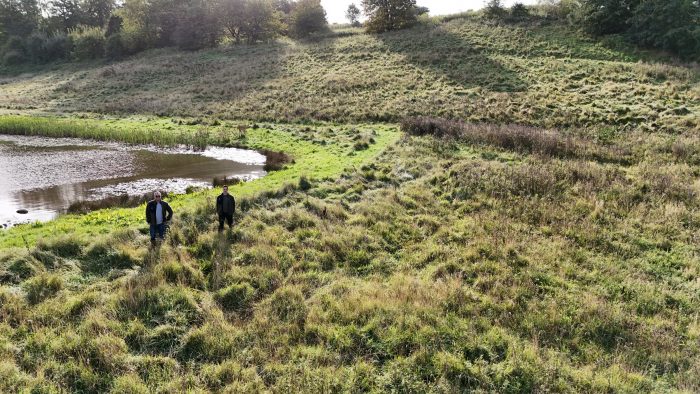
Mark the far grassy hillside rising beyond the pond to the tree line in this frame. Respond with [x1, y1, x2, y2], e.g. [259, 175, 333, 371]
[0, 19, 700, 132]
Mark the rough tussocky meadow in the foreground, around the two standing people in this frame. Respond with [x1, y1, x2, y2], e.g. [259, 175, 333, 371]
[0, 118, 700, 392]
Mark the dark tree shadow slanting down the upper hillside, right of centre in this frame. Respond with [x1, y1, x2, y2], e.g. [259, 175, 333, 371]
[378, 26, 528, 92]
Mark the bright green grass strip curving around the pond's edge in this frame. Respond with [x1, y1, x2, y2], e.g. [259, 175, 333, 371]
[0, 116, 400, 249]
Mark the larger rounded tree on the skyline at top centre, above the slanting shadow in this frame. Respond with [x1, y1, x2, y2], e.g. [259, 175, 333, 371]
[362, 0, 416, 33]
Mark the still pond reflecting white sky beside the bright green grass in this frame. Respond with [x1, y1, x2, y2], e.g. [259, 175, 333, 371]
[0, 134, 265, 229]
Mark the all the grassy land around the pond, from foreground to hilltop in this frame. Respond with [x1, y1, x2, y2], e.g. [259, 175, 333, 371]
[0, 14, 700, 393]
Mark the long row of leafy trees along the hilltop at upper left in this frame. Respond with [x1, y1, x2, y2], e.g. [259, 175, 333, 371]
[0, 0, 328, 64]
